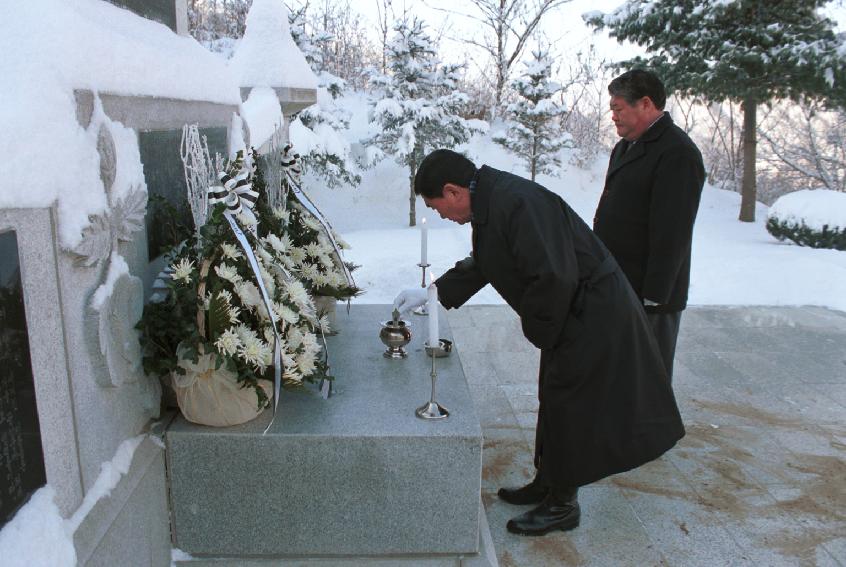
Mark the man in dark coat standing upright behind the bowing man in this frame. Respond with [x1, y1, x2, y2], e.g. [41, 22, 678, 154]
[593, 69, 705, 379]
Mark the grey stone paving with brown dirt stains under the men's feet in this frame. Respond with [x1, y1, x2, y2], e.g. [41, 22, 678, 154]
[449, 306, 846, 567]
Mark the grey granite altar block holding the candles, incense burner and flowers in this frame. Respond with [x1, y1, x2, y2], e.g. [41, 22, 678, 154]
[166, 305, 496, 567]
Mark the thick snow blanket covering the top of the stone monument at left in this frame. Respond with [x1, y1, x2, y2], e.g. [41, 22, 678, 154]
[0, 0, 234, 248]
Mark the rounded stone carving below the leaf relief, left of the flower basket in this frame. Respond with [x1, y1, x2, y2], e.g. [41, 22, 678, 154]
[98, 274, 144, 386]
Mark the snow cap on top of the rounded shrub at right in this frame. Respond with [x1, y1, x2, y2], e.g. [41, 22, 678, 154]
[767, 189, 846, 231]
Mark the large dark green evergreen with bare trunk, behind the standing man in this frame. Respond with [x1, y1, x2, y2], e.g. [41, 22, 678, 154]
[585, 0, 846, 222]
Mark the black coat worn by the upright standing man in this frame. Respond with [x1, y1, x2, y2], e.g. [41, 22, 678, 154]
[593, 113, 705, 313]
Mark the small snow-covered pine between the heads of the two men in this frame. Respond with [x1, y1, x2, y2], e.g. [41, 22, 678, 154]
[494, 48, 572, 181]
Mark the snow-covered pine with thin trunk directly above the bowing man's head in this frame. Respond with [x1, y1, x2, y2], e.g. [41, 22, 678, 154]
[363, 17, 478, 226]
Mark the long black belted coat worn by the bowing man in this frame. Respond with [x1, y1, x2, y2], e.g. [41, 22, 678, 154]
[437, 166, 684, 487]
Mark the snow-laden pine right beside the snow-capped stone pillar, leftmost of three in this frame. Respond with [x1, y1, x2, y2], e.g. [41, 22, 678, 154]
[288, 6, 361, 187]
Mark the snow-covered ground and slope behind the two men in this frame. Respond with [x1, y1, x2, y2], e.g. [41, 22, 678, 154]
[304, 93, 846, 311]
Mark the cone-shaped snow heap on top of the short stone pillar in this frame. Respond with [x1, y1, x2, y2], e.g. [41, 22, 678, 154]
[229, 0, 317, 89]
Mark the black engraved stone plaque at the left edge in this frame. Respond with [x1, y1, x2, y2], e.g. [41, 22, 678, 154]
[0, 231, 47, 526]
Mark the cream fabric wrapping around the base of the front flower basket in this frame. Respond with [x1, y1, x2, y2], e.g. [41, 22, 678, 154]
[172, 354, 273, 427]
